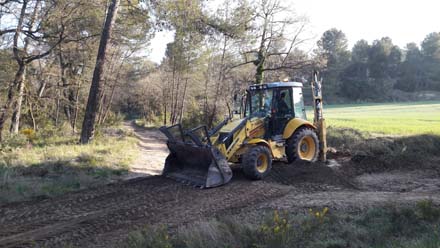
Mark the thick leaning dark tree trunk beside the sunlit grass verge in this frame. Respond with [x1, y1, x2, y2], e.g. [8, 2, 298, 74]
[80, 0, 120, 144]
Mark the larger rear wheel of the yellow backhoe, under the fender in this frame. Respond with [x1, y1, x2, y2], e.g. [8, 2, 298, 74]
[286, 127, 319, 163]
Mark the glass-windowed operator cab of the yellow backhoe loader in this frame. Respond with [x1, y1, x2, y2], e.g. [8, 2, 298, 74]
[244, 82, 306, 138]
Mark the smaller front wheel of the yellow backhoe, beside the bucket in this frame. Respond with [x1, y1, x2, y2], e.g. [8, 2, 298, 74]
[242, 145, 272, 180]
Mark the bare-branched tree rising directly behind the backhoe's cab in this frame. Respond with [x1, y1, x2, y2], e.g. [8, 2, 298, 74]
[235, 0, 311, 84]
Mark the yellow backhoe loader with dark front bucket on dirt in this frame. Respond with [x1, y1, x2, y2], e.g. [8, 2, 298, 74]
[160, 72, 326, 188]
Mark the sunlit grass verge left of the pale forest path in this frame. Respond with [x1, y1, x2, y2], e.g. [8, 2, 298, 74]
[0, 127, 138, 204]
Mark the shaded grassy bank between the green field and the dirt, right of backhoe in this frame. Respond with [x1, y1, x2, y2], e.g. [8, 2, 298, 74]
[327, 128, 440, 174]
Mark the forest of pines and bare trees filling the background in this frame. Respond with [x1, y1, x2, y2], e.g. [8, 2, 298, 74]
[0, 0, 440, 140]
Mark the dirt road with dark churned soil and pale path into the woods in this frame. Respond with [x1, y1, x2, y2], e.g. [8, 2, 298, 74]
[0, 125, 440, 247]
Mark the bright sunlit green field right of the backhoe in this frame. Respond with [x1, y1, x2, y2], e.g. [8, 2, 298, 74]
[308, 101, 440, 135]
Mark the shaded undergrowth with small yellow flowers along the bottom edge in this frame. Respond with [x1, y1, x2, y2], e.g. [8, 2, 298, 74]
[121, 200, 440, 248]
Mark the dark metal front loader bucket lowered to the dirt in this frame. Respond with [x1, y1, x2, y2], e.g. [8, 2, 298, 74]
[160, 125, 232, 188]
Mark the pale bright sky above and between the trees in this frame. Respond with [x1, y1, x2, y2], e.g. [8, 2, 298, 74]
[149, 0, 440, 63]
